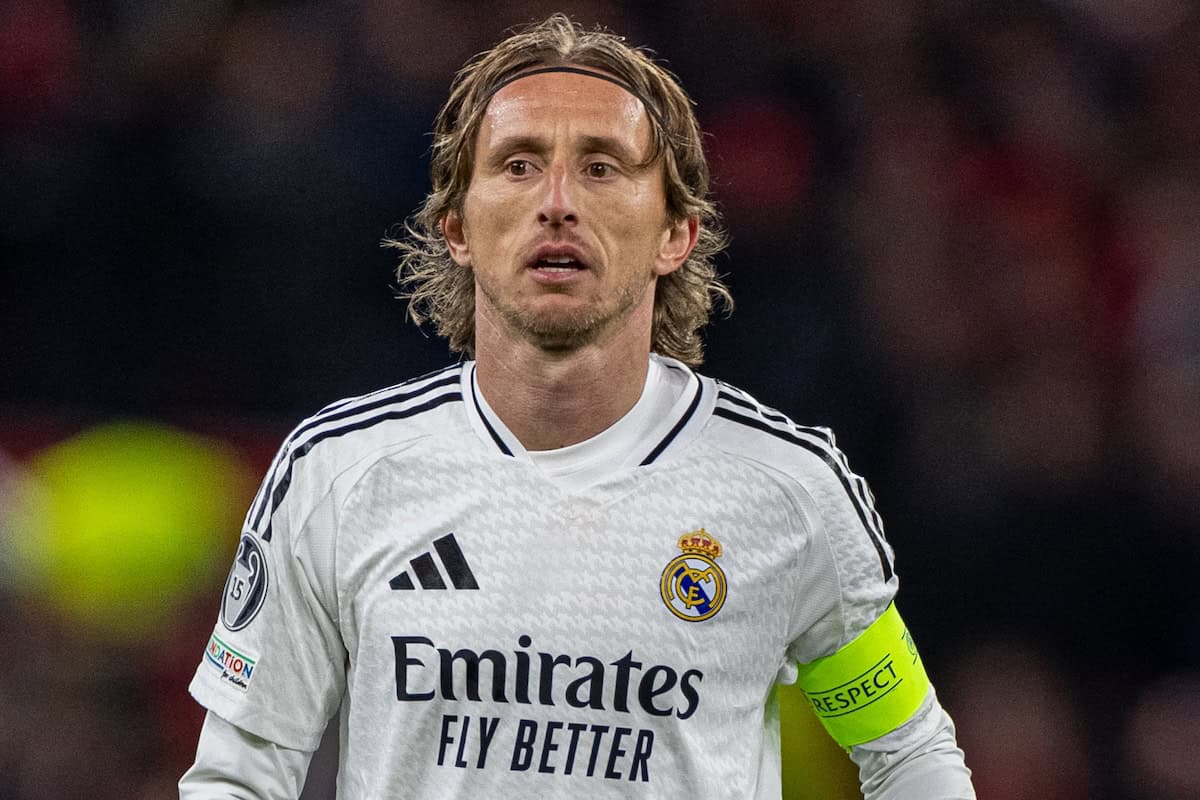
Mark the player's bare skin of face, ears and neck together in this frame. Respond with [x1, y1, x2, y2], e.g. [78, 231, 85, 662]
[443, 72, 700, 450]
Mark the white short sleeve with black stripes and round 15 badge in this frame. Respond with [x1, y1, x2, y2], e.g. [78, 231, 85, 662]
[190, 445, 347, 751]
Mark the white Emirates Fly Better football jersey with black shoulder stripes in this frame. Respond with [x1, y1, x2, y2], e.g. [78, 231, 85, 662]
[191, 356, 896, 800]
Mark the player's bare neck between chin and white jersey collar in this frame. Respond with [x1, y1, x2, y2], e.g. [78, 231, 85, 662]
[475, 303, 650, 451]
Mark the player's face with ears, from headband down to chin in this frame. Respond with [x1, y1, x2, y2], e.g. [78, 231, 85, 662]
[443, 72, 697, 350]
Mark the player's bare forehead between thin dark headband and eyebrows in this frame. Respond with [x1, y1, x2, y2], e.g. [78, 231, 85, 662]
[479, 72, 650, 152]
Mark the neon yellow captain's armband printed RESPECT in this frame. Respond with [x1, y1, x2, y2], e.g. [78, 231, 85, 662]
[798, 603, 929, 750]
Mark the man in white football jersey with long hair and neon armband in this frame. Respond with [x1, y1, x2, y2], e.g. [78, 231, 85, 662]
[180, 16, 974, 800]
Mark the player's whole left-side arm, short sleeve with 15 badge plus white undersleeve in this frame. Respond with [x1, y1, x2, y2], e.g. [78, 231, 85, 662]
[180, 429, 348, 786]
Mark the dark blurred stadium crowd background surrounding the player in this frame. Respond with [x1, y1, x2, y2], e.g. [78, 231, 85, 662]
[0, 0, 1200, 800]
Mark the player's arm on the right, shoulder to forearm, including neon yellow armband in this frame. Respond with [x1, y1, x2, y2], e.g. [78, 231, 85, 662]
[768, 435, 976, 800]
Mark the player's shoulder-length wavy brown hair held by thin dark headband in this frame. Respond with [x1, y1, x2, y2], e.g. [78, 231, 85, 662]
[384, 13, 733, 365]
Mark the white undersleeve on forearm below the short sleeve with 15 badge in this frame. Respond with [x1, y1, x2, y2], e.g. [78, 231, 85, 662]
[179, 711, 312, 800]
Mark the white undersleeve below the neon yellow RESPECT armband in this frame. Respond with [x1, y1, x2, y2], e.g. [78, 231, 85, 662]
[850, 688, 976, 800]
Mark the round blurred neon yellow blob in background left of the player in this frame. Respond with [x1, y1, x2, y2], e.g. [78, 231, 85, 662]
[17, 422, 252, 637]
